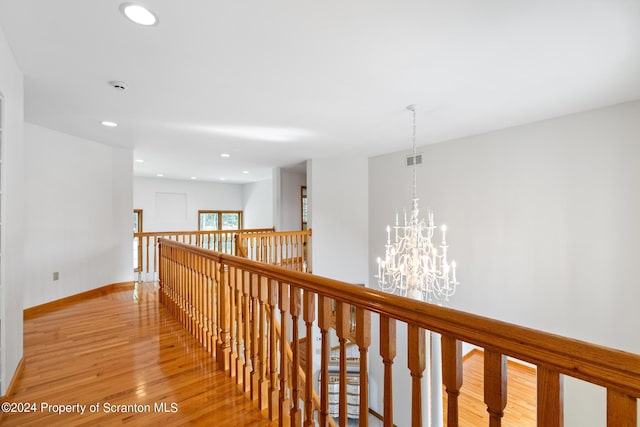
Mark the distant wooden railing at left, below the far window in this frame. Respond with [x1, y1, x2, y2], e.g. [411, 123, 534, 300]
[133, 228, 274, 281]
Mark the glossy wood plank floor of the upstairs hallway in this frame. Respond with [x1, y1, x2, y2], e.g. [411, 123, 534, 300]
[0, 284, 277, 426]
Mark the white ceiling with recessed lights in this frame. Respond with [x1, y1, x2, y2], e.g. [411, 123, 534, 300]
[0, 0, 640, 182]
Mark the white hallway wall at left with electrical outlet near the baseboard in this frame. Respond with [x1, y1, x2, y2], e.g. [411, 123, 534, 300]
[24, 123, 133, 308]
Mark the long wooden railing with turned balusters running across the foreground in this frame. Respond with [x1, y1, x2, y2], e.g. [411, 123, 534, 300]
[160, 240, 640, 427]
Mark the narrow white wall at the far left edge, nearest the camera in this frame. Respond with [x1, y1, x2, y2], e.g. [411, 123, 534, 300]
[0, 23, 25, 395]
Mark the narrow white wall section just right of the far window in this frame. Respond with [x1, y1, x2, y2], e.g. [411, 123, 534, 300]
[242, 179, 274, 228]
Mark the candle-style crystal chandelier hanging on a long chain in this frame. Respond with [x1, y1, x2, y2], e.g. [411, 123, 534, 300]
[375, 105, 458, 305]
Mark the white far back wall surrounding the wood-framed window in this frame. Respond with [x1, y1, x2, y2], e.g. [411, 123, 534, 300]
[133, 177, 243, 231]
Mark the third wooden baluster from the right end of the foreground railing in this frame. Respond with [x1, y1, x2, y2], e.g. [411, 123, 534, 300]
[484, 349, 507, 427]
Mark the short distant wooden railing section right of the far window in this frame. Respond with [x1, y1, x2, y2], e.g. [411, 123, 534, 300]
[236, 230, 311, 273]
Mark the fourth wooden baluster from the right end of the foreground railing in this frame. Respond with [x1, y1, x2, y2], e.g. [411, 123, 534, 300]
[441, 335, 462, 427]
